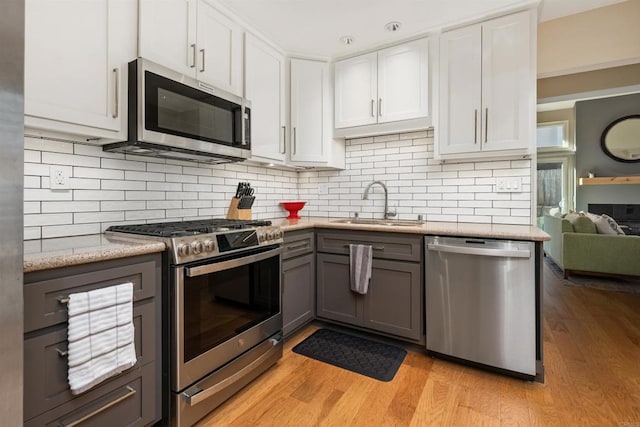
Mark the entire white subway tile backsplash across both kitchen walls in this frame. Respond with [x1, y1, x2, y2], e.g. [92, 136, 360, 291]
[24, 131, 531, 239]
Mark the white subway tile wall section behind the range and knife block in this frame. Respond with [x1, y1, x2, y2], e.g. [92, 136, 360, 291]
[24, 137, 298, 240]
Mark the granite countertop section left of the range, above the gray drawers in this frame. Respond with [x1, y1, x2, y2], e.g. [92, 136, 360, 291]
[24, 234, 166, 273]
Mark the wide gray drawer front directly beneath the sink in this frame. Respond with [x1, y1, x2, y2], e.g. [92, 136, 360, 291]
[316, 230, 422, 262]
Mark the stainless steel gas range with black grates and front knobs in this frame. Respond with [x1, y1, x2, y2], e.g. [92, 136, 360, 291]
[107, 219, 283, 427]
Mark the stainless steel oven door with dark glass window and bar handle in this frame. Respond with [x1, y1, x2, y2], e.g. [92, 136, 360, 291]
[171, 246, 282, 392]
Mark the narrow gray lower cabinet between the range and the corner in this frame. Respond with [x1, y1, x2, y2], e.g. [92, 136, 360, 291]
[282, 231, 316, 336]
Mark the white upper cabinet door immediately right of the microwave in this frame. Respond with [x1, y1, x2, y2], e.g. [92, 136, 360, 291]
[244, 33, 286, 162]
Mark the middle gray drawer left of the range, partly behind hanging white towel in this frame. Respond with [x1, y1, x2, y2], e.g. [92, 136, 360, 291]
[24, 300, 157, 420]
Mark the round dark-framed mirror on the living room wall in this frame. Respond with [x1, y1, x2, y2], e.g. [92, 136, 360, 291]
[600, 115, 640, 163]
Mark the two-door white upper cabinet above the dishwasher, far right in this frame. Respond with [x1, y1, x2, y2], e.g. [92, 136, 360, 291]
[435, 11, 535, 159]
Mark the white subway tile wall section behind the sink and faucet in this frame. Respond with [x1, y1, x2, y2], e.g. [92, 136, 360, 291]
[298, 132, 531, 224]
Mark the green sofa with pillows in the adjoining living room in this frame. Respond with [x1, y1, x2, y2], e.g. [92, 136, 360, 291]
[543, 215, 640, 279]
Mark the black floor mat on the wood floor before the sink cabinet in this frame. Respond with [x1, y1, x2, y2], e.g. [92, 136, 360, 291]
[293, 329, 407, 381]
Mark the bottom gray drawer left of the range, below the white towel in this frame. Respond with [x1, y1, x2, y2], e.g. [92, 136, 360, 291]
[24, 363, 160, 427]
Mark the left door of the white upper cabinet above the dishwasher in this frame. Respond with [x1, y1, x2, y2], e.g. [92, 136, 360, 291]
[438, 25, 482, 154]
